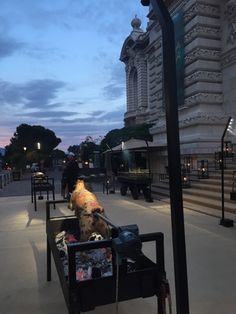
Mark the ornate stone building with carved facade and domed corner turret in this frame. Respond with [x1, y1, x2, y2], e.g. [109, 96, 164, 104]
[120, 0, 236, 175]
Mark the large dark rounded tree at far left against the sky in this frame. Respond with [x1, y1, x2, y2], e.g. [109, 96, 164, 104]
[5, 124, 61, 168]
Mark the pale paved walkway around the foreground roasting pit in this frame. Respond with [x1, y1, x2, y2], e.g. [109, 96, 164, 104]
[0, 174, 236, 314]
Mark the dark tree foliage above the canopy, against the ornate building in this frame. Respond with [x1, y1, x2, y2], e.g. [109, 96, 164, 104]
[101, 123, 152, 151]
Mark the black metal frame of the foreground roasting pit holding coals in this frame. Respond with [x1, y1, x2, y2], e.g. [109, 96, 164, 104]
[46, 200, 166, 314]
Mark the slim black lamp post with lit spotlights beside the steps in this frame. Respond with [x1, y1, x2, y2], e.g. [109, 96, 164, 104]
[220, 117, 234, 227]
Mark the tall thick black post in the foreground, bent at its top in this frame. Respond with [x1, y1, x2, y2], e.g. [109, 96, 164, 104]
[141, 0, 189, 314]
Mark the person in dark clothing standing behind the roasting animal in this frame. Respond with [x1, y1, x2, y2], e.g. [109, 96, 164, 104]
[61, 153, 79, 198]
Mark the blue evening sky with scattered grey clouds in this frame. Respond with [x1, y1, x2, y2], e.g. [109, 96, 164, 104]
[0, 0, 148, 150]
